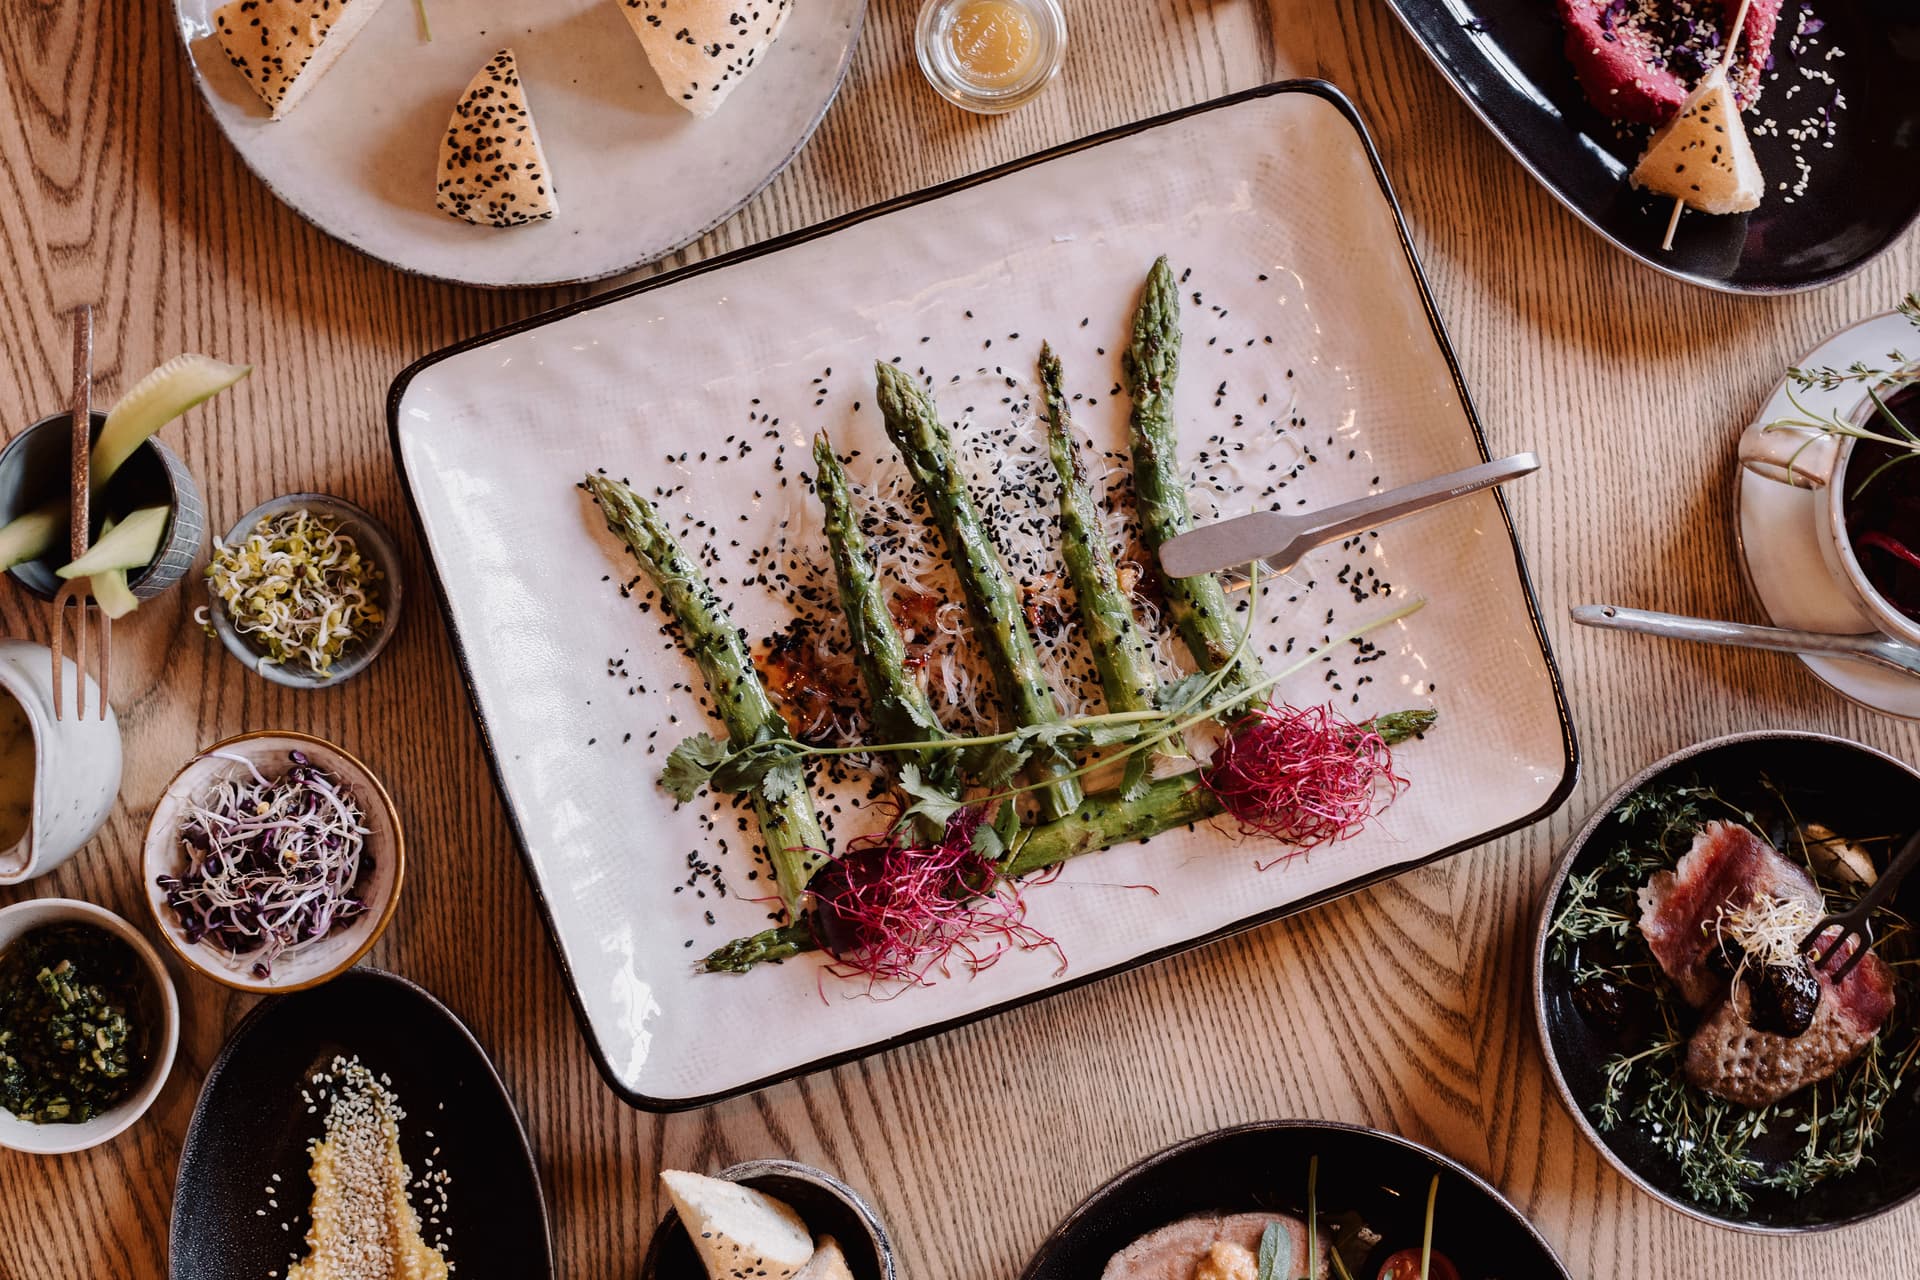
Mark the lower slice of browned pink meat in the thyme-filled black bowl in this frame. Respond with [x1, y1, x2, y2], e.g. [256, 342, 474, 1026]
[1686, 940, 1893, 1107]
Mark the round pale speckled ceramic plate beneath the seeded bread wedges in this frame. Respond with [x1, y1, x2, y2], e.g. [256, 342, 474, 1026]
[175, 0, 866, 286]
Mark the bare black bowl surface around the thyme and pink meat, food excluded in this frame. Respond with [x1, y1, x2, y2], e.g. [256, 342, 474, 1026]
[1534, 729, 1920, 1236]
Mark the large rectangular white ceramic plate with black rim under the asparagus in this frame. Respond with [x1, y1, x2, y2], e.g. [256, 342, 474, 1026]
[390, 84, 1574, 1107]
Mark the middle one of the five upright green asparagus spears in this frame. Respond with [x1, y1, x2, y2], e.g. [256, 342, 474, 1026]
[874, 363, 1081, 821]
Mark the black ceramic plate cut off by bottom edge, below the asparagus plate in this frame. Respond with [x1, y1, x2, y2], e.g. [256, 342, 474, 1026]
[1025, 1121, 1567, 1280]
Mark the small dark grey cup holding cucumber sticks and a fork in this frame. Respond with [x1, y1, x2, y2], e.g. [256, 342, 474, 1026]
[0, 413, 207, 601]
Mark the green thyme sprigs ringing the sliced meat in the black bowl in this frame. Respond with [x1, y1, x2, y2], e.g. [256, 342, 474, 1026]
[1548, 777, 1920, 1213]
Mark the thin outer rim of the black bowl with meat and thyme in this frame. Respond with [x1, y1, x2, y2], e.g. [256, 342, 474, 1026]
[1532, 727, 1920, 1236]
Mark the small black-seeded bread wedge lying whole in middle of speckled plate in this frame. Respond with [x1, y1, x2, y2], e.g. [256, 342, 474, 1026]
[434, 48, 561, 226]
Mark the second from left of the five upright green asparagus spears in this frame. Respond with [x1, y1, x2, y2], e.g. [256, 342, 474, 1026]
[814, 434, 950, 777]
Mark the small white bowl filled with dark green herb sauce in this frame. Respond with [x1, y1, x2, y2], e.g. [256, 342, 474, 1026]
[0, 898, 180, 1155]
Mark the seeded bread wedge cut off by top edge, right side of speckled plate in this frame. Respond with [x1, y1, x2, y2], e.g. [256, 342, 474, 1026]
[616, 0, 793, 117]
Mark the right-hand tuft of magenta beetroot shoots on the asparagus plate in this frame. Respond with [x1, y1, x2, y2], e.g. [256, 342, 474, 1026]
[1200, 702, 1407, 865]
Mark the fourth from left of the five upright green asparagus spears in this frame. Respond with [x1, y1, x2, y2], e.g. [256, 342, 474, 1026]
[1041, 344, 1160, 712]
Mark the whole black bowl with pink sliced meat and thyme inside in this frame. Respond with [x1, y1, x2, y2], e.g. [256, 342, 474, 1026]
[1534, 731, 1920, 1234]
